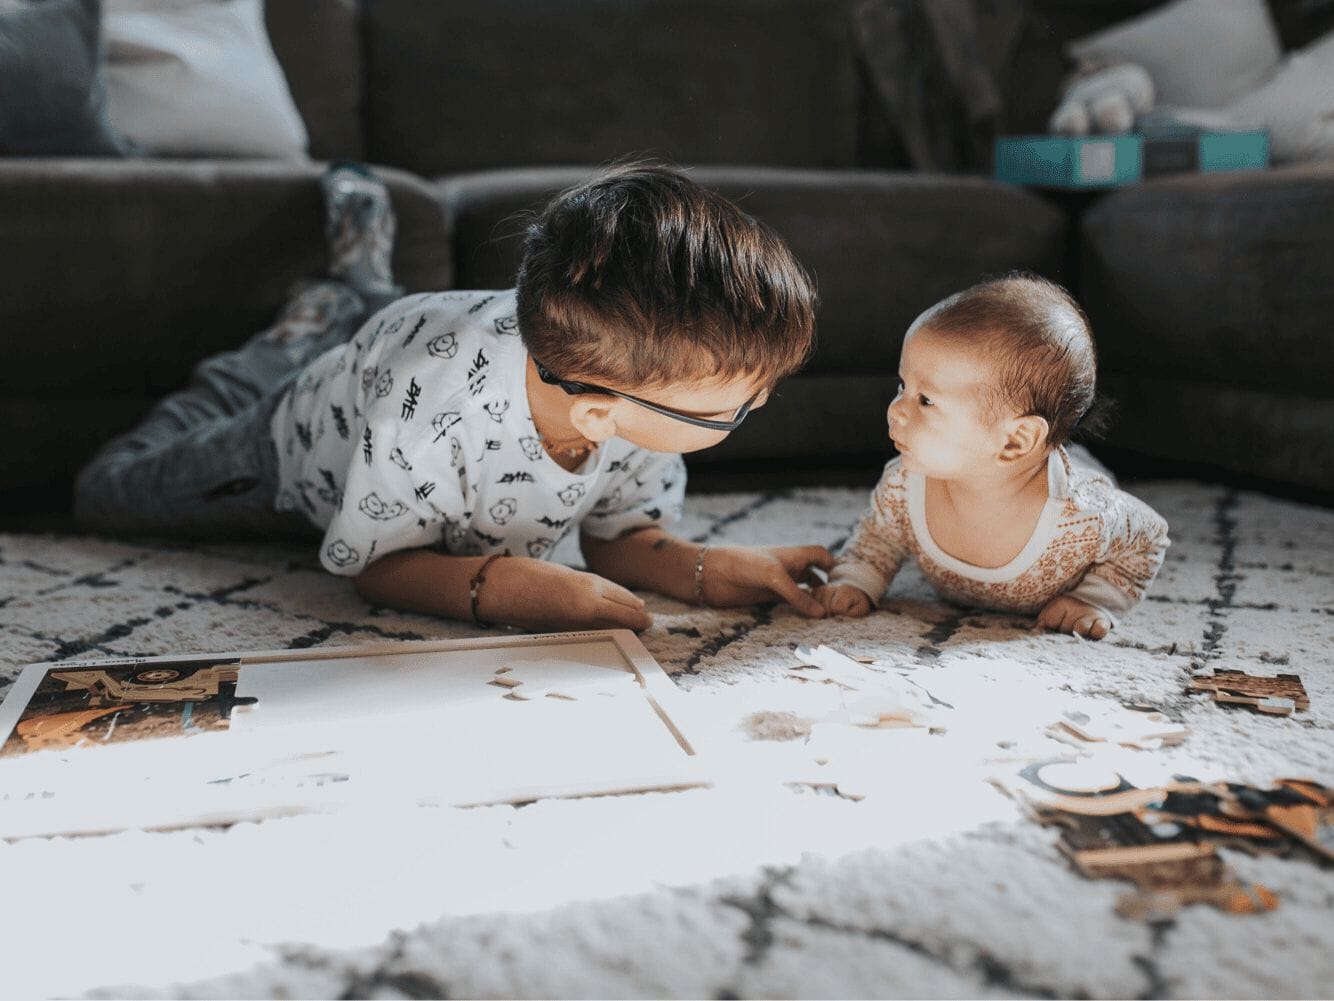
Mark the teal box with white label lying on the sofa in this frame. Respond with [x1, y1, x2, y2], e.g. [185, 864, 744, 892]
[995, 128, 1269, 188]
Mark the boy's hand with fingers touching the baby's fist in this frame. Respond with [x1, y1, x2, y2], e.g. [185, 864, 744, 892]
[703, 546, 834, 619]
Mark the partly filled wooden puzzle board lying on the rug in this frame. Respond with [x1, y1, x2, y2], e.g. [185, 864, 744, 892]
[0, 630, 707, 838]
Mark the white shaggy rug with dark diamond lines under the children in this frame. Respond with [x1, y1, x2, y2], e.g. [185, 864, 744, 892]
[0, 483, 1334, 998]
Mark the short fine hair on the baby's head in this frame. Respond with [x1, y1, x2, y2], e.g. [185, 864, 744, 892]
[912, 271, 1103, 446]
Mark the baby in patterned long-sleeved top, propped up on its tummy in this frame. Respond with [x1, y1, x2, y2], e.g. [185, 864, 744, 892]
[818, 275, 1169, 639]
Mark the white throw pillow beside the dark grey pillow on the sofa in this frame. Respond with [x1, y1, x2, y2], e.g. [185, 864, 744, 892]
[104, 0, 307, 159]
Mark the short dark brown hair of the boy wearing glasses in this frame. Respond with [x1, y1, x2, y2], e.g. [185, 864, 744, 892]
[518, 163, 815, 387]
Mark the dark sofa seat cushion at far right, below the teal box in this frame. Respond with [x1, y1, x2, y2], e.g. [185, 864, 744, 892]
[1081, 164, 1334, 396]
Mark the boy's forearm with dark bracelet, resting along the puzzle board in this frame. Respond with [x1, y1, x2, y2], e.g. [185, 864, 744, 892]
[355, 549, 652, 630]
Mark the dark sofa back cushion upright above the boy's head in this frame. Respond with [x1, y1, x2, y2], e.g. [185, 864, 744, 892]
[364, 0, 856, 175]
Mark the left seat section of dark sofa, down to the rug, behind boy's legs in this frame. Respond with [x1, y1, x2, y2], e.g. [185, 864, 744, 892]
[0, 160, 452, 512]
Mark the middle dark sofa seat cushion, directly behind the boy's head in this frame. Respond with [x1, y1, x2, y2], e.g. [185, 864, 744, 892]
[439, 167, 1066, 374]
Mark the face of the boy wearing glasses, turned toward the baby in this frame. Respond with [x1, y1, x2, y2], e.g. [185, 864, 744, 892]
[575, 375, 768, 452]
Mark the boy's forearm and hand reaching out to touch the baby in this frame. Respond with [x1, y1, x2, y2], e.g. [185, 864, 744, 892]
[579, 526, 834, 618]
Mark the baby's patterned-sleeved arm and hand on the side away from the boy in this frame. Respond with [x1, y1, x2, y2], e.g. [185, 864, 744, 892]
[1038, 490, 1170, 639]
